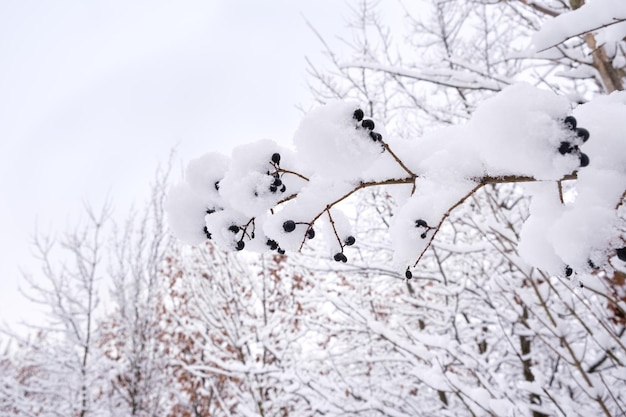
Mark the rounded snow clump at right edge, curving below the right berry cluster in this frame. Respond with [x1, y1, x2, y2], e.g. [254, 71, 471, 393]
[520, 92, 626, 273]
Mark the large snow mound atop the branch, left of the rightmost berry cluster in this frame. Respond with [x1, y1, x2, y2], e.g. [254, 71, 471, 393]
[403, 84, 578, 181]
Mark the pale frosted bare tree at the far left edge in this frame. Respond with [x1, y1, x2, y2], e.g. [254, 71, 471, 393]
[2, 207, 110, 417]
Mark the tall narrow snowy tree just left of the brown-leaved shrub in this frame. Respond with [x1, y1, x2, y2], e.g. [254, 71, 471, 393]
[100, 164, 177, 416]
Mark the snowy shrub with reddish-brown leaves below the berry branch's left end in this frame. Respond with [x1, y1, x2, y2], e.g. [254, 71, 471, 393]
[161, 245, 313, 416]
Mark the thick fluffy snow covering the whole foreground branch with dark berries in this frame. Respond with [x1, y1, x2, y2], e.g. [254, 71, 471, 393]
[168, 84, 626, 278]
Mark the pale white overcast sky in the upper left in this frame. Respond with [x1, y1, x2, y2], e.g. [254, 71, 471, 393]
[0, 0, 388, 323]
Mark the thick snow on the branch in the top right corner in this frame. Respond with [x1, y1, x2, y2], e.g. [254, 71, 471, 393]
[533, 0, 626, 51]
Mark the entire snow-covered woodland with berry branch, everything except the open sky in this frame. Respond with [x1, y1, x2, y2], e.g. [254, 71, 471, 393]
[0, 0, 626, 417]
